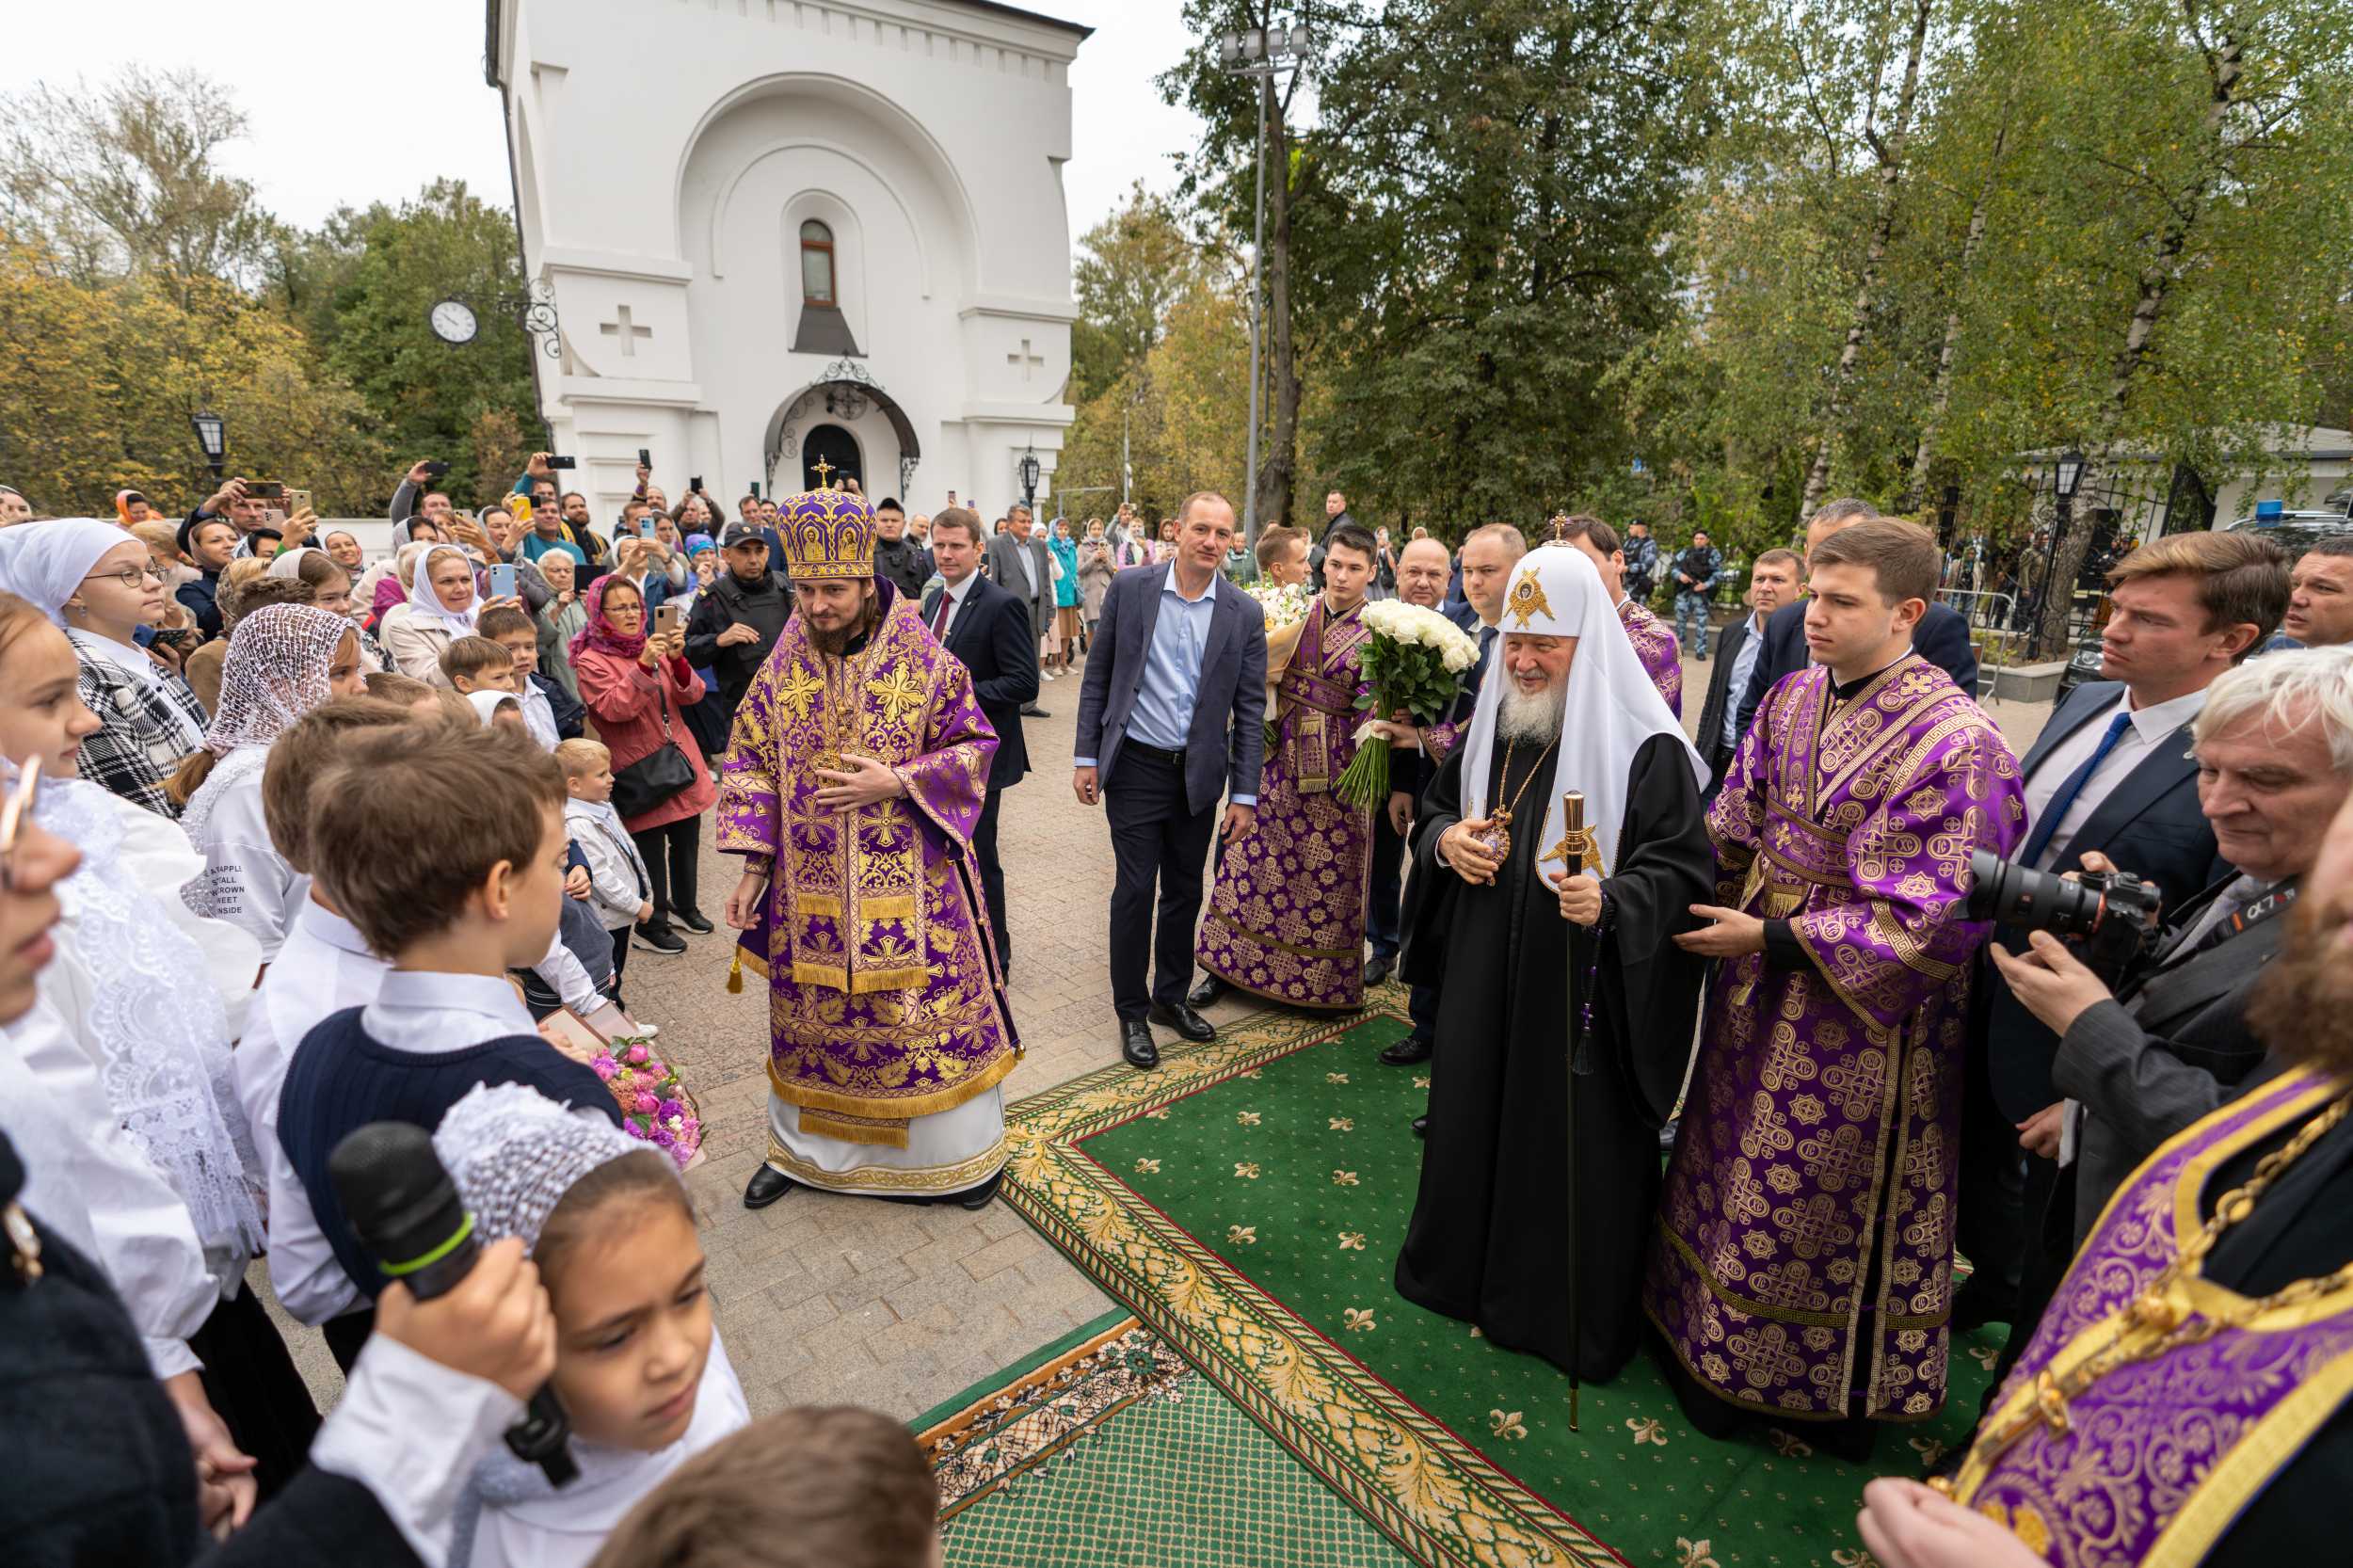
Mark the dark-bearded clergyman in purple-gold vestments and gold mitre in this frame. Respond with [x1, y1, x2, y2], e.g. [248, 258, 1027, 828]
[718, 489, 1016, 1208]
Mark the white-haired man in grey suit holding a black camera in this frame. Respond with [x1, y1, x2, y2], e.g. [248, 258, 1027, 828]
[1993, 648, 2353, 1264]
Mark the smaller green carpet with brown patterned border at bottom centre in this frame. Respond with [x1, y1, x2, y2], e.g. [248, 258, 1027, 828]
[916, 1311, 1410, 1568]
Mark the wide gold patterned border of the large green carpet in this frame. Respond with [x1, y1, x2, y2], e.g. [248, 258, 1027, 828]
[1005, 984, 1626, 1568]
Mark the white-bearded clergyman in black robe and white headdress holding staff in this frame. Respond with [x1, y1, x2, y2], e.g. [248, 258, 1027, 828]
[1398, 544, 1713, 1380]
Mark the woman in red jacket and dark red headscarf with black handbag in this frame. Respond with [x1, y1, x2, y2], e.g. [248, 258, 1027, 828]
[572, 567, 718, 953]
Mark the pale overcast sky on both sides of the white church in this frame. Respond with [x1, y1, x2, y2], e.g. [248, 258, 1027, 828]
[0, 0, 1198, 250]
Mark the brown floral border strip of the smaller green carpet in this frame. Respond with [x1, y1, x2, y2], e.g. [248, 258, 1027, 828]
[916, 1316, 1195, 1523]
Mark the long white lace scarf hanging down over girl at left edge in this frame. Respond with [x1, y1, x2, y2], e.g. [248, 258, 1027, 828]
[30, 767, 264, 1264]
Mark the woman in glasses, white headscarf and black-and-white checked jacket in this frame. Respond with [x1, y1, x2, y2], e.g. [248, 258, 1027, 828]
[0, 518, 205, 817]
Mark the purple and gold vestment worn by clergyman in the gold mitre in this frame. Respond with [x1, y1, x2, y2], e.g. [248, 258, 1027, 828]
[718, 596, 1016, 1146]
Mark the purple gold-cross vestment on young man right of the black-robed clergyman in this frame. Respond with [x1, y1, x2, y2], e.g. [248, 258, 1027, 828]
[1642, 654, 2026, 1419]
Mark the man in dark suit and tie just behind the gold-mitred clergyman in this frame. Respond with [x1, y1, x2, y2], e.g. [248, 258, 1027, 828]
[922, 506, 1038, 972]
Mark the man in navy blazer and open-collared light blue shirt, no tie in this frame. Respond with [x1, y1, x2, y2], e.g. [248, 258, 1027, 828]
[1078, 489, 1266, 1069]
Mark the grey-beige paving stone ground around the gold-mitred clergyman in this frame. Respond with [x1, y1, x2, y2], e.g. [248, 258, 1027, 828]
[254, 621, 2050, 1419]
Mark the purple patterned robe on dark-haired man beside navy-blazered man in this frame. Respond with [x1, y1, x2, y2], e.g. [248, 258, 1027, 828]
[1193, 598, 1372, 1008]
